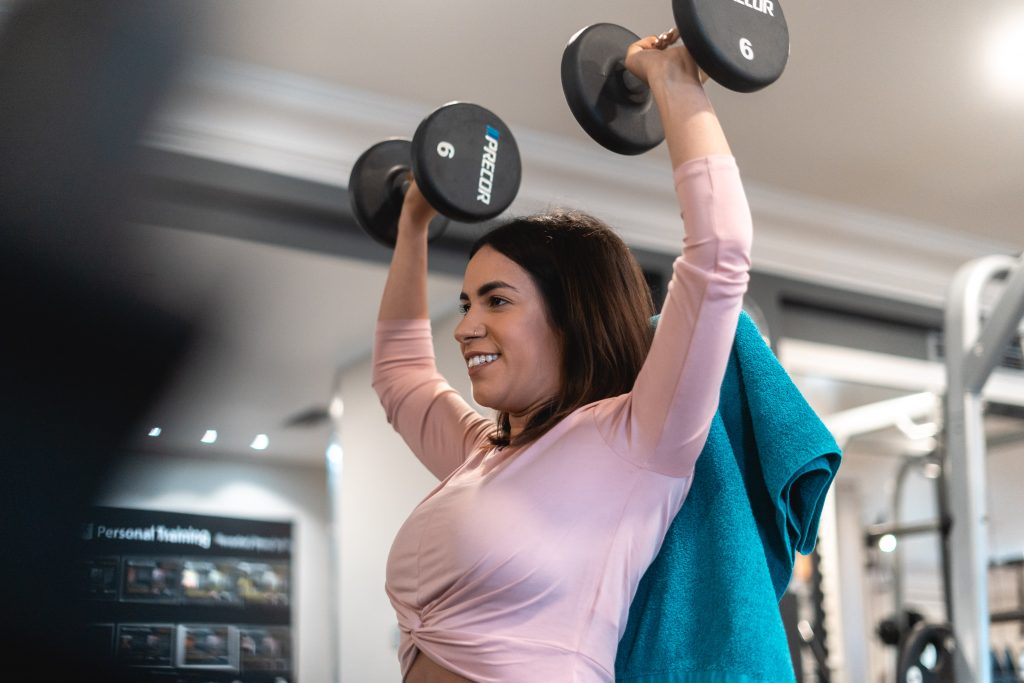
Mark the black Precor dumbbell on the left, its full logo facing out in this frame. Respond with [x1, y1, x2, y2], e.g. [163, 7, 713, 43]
[348, 102, 522, 248]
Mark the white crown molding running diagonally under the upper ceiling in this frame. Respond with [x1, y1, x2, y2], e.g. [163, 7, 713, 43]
[146, 58, 1014, 305]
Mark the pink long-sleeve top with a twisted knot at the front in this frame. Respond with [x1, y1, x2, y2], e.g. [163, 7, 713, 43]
[373, 157, 751, 683]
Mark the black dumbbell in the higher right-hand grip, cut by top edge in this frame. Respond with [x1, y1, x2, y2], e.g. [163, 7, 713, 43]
[561, 0, 790, 155]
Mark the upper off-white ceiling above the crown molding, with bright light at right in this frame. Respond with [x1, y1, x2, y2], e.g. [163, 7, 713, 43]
[197, 0, 1024, 248]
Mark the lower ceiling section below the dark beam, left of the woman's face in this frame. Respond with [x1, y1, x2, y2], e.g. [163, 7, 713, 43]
[123, 225, 461, 465]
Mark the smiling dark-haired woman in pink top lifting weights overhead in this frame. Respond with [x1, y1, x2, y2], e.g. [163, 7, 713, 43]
[374, 31, 751, 683]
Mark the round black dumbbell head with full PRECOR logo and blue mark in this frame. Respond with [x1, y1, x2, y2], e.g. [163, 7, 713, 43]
[412, 102, 522, 223]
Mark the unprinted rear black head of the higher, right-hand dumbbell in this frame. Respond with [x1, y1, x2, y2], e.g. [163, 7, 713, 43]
[561, 24, 665, 155]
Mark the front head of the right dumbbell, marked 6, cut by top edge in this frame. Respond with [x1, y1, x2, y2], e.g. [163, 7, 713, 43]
[672, 0, 790, 92]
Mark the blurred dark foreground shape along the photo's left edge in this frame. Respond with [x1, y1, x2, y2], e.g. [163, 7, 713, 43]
[0, 0, 193, 681]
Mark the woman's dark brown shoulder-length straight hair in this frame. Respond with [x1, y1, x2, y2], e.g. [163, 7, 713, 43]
[470, 210, 654, 446]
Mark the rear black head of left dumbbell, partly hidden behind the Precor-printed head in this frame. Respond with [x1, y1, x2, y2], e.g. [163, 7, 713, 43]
[348, 138, 447, 248]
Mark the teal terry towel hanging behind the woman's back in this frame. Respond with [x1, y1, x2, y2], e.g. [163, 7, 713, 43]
[615, 313, 841, 683]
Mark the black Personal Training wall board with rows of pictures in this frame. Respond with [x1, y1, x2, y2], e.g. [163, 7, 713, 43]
[73, 508, 295, 683]
